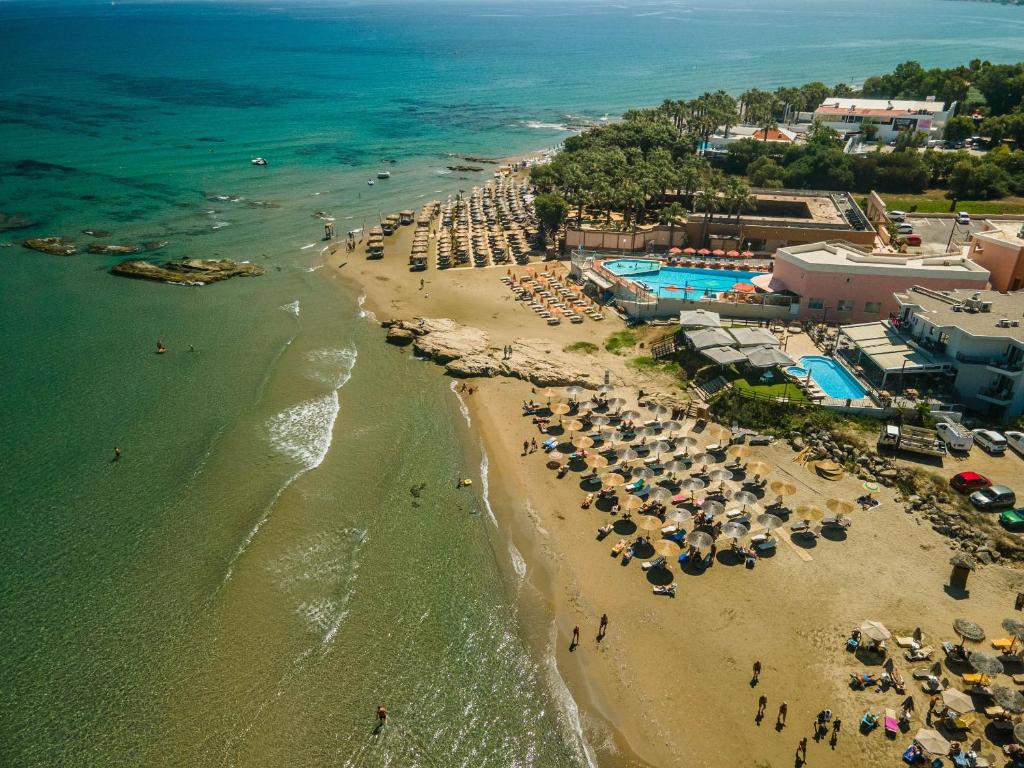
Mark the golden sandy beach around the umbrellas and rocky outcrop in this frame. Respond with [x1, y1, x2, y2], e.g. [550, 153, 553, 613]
[327, 208, 1019, 766]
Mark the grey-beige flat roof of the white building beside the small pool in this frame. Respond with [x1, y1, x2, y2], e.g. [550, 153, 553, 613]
[896, 286, 1024, 341]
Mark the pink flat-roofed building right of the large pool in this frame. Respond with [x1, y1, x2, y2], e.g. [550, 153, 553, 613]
[752, 242, 988, 325]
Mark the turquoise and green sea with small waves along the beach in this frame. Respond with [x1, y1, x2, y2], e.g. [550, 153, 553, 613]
[0, 0, 1024, 767]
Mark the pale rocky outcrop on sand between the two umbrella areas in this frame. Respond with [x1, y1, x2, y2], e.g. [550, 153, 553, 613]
[382, 317, 599, 387]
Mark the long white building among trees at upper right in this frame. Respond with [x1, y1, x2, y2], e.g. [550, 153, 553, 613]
[814, 96, 956, 142]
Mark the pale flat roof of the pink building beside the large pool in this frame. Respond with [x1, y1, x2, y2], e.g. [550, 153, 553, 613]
[775, 241, 989, 276]
